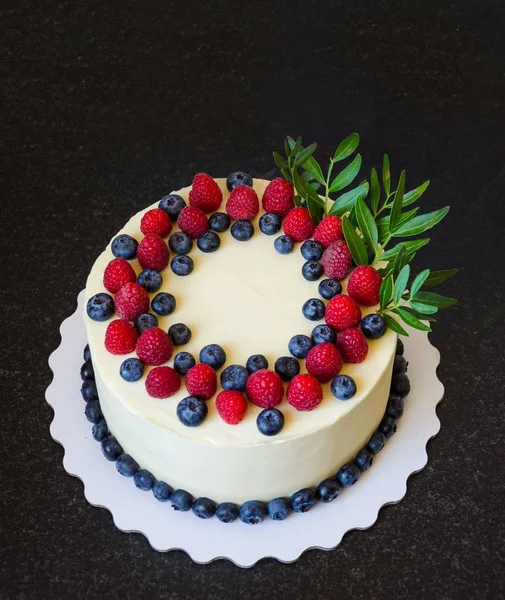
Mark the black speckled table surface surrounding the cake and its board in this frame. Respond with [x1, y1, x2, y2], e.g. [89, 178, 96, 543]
[0, 0, 505, 599]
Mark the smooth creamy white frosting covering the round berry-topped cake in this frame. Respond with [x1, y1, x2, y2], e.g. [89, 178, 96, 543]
[85, 179, 396, 502]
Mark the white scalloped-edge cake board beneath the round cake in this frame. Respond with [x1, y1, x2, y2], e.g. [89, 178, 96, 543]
[46, 291, 444, 567]
